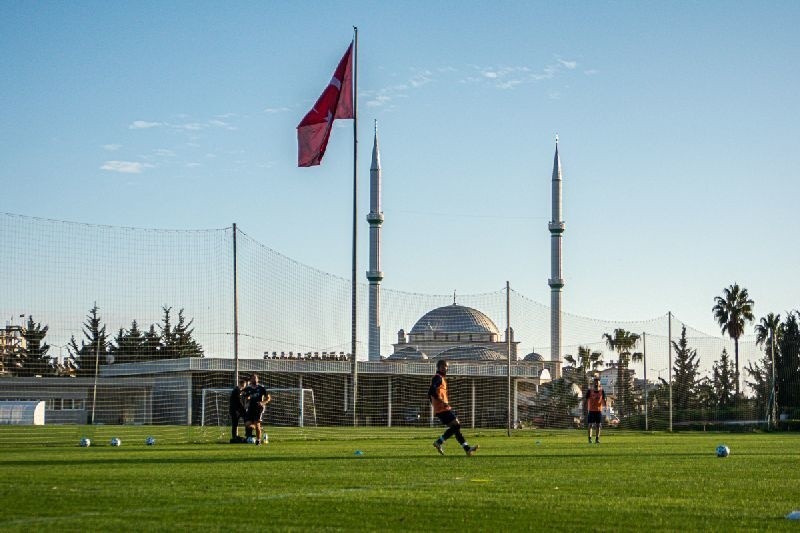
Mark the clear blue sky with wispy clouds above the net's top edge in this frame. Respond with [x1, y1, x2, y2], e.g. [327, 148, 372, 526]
[0, 0, 800, 334]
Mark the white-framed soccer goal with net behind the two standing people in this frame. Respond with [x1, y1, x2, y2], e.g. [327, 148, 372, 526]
[201, 388, 317, 427]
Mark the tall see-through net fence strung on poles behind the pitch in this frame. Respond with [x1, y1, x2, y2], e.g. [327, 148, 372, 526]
[0, 214, 800, 441]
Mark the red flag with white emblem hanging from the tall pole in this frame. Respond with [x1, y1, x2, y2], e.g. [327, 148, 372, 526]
[297, 43, 354, 167]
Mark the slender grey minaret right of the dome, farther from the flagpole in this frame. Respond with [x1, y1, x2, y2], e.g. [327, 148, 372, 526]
[547, 135, 564, 377]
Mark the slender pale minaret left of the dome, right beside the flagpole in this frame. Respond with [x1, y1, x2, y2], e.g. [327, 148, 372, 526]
[367, 120, 383, 361]
